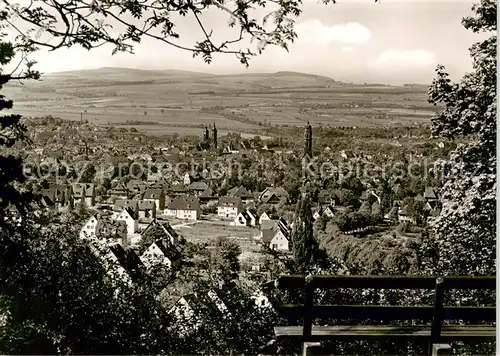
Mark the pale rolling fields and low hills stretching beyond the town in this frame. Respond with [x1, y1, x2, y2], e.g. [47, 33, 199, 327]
[5, 68, 436, 135]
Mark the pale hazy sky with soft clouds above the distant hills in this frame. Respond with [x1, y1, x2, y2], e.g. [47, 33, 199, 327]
[4, 0, 488, 83]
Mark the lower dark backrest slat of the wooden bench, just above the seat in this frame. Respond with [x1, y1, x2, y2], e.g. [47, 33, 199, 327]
[277, 305, 496, 322]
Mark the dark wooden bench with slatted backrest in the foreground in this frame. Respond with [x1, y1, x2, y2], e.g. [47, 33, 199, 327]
[275, 276, 496, 354]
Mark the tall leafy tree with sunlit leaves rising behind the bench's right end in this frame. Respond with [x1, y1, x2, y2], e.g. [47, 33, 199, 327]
[422, 0, 497, 275]
